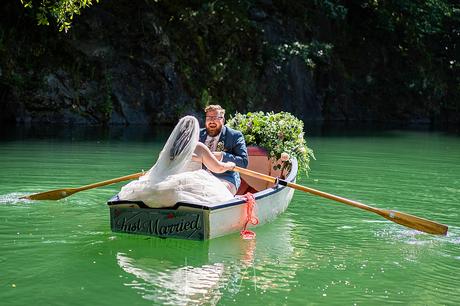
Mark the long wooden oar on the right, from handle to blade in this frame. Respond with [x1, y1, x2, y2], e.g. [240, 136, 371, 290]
[234, 167, 448, 235]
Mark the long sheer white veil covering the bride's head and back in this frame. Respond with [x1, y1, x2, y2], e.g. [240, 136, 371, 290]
[149, 116, 200, 182]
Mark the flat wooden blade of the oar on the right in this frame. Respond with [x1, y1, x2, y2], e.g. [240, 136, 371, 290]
[381, 210, 449, 236]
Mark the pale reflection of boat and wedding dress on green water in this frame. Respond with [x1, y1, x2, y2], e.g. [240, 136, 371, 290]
[115, 218, 297, 305]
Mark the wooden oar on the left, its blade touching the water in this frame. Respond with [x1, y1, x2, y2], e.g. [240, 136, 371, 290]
[20, 172, 144, 200]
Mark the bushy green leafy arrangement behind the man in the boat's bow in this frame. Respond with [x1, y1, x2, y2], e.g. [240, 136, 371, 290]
[227, 112, 315, 174]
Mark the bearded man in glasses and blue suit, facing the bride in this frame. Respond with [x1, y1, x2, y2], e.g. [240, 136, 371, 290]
[200, 105, 248, 195]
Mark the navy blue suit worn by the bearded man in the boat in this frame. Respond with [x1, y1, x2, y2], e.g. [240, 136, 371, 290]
[200, 126, 248, 190]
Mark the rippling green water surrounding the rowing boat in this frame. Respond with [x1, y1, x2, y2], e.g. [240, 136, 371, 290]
[0, 128, 460, 305]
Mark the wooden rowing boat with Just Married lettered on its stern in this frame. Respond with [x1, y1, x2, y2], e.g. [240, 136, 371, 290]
[107, 147, 298, 240]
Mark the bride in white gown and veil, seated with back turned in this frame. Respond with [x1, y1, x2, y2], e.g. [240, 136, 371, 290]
[118, 116, 235, 207]
